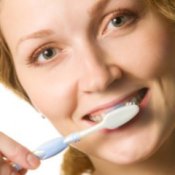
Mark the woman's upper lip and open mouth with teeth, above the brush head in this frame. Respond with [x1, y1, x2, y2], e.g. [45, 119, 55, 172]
[83, 88, 148, 123]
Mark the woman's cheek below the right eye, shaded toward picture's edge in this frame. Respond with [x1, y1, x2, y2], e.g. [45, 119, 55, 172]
[107, 20, 175, 79]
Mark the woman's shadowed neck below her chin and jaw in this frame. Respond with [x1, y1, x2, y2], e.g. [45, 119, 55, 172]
[91, 131, 175, 175]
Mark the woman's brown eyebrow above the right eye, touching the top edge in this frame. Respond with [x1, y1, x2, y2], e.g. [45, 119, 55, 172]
[89, 0, 110, 16]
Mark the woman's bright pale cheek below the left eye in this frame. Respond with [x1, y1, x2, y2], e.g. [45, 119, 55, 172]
[15, 68, 77, 123]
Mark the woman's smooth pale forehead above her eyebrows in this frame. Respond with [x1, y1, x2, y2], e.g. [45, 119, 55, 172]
[0, 0, 104, 33]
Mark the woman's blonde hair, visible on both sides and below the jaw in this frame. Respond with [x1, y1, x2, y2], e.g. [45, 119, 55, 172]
[0, 0, 175, 175]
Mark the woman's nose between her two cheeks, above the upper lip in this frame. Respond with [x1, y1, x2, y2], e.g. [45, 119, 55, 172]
[80, 46, 122, 93]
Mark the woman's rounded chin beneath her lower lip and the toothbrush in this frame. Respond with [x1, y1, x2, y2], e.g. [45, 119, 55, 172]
[94, 135, 163, 165]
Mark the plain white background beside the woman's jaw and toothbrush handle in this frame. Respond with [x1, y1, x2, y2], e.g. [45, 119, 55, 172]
[0, 84, 62, 175]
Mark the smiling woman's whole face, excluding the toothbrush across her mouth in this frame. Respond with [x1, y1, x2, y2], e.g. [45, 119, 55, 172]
[0, 0, 175, 164]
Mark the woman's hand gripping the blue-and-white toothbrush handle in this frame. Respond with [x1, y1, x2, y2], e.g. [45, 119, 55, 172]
[0, 132, 40, 175]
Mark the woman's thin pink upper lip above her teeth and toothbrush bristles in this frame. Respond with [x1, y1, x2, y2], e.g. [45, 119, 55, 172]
[84, 89, 147, 116]
